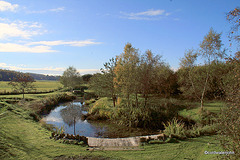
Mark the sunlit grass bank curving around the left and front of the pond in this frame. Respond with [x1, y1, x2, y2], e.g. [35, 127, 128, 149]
[0, 82, 227, 159]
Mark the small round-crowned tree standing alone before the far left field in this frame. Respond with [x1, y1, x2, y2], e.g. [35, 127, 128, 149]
[8, 73, 35, 99]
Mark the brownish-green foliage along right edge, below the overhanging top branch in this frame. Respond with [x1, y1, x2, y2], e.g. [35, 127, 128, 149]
[219, 52, 240, 159]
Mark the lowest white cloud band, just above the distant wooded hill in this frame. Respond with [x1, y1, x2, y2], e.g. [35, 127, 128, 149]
[0, 63, 100, 75]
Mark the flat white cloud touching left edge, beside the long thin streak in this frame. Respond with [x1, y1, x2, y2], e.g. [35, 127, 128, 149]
[0, 43, 56, 53]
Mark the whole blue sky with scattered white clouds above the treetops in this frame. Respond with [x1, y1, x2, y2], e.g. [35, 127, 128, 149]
[0, 0, 240, 75]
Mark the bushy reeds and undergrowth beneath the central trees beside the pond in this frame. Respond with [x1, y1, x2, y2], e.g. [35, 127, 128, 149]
[88, 98, 183, 129]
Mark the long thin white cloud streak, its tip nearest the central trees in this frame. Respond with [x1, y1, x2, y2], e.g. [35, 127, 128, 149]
[27, 39, 101, 47]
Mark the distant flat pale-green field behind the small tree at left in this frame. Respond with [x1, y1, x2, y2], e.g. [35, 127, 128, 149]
[0, 81, 63, 92]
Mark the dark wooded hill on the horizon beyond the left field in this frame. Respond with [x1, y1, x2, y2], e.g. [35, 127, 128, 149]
[0, 69, 60, 81]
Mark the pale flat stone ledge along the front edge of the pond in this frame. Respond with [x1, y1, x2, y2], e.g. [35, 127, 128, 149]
[87, 134, 165, 147]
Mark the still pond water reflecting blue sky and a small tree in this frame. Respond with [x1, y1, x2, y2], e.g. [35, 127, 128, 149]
[43, 101, 157, 138]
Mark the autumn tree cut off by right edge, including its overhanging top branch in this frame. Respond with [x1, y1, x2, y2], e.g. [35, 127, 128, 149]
[219, 7, 240, 159]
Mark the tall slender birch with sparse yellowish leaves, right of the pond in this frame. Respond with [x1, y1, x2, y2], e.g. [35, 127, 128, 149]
[179, 28, 225, 109]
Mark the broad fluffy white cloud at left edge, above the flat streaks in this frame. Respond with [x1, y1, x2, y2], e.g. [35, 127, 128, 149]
[0, 19, 45, 39]
